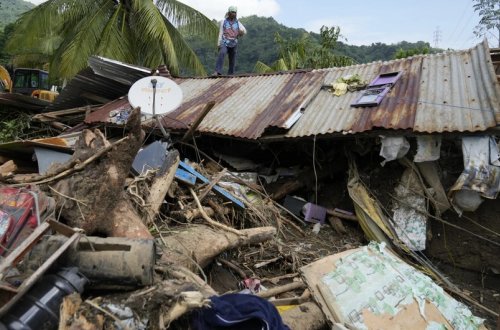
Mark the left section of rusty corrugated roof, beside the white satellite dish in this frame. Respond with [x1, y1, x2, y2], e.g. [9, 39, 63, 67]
[163, 72, 324, 139]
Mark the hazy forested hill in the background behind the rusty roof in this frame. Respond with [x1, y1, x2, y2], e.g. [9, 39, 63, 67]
[187, 16, 438, 73]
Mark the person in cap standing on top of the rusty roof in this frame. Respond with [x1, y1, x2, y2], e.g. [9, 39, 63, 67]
[214, 6, 247, 76]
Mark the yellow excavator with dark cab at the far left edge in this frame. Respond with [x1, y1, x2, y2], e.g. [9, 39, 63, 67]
[0, 65, 59, 102]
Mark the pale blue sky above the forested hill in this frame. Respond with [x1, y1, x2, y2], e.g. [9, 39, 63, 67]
[25, 0, 486, 49]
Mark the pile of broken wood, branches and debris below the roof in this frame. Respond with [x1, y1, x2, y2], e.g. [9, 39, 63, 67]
[0, 49, 500, 329]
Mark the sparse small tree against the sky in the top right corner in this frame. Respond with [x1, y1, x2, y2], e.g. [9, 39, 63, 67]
[473, 0, 500, 47]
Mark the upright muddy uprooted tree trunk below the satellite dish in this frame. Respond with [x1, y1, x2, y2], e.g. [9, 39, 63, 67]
[51, 109, 152, 238]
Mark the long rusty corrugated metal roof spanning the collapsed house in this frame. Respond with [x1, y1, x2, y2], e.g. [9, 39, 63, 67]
[81, 42, 500, 139]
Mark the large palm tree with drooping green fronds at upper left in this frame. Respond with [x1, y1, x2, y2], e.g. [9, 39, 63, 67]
[7, 0, 217, 78]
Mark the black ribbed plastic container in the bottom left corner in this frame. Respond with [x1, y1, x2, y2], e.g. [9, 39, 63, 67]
[0, 267, 88, 330]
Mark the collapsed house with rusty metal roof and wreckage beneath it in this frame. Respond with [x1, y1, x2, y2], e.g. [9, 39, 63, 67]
[0, 38, 500, 329]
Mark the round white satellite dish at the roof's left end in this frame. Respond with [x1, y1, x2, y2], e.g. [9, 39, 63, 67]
[128, 76, 182, 116]
